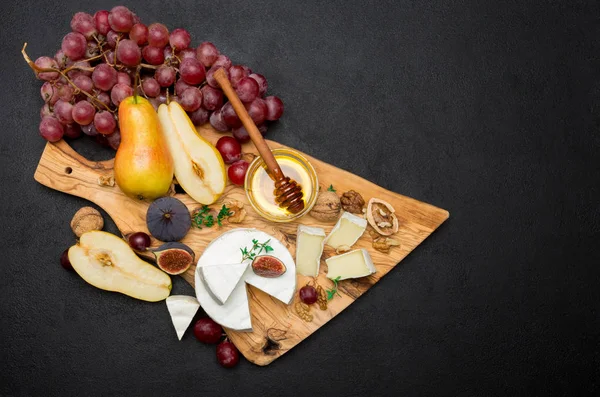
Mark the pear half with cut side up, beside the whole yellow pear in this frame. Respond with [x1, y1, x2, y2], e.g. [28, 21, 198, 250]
[158, 102, 227, 205]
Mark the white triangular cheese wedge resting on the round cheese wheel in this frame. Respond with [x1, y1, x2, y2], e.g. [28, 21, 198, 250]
[200, 263, 248, 305]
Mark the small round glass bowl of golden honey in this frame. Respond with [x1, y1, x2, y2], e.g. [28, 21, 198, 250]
[244, 149, 319, 222]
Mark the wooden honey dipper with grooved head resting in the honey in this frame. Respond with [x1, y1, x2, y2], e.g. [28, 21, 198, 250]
[213, 68, 304, 214]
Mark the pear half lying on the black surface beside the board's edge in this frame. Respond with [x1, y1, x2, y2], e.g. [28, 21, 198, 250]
[69, 231, 171, 302]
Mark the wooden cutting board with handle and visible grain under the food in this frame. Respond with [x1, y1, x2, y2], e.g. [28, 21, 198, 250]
[35, 125, 449, 365]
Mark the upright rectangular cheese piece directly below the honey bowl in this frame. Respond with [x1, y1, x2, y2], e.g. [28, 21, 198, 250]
[296, 225, 325, 277]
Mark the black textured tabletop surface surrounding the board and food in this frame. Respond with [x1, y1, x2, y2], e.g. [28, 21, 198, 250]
[0, 0, 600, 396]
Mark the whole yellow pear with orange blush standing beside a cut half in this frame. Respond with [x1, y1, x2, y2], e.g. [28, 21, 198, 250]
[114, 95, 173, 200]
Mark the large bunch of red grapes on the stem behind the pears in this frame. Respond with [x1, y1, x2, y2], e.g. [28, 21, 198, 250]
[32, 6, 283, 150]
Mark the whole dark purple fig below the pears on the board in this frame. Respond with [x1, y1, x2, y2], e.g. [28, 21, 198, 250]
[146, 197, 192, 241]
